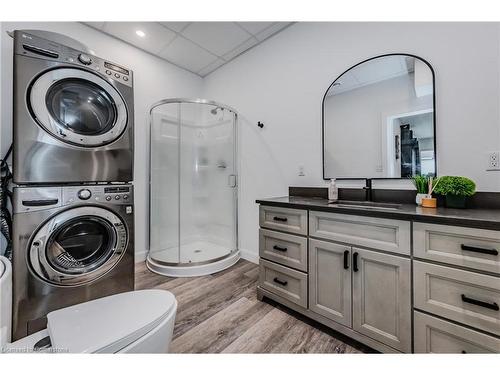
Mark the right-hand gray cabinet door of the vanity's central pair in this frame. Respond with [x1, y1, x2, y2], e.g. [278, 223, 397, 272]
[352, 248, 411, 353]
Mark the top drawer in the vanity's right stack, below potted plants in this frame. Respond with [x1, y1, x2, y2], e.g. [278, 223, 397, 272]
[413, 223, 500, 273]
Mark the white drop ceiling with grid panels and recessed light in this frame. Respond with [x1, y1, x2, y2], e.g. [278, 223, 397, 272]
[82, 22, 291, 77]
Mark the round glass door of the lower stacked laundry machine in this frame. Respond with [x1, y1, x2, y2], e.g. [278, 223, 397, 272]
[28, 207, 128, 286]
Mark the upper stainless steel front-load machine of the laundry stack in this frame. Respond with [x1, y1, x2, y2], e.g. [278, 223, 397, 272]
[13, 31, 134, 185]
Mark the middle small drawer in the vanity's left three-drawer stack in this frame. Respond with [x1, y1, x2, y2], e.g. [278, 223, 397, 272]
[259, 229, 307, 271]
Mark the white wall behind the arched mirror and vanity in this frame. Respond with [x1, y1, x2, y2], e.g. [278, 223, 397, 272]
[204, 23, 500, 260]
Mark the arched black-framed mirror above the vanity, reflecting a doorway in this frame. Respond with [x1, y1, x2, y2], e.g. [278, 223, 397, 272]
[323, 54, 436, 179]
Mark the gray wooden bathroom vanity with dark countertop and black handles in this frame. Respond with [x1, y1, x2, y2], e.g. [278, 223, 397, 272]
[257, 196, 500, 353]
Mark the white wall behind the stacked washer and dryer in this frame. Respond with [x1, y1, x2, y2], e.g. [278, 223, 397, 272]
[0, 22, 203, 259]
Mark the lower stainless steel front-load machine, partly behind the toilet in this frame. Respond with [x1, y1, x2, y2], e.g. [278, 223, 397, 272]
[12, 184, 134, 340]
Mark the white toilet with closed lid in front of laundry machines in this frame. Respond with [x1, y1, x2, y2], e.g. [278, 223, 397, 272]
[0, 256, 177, 353]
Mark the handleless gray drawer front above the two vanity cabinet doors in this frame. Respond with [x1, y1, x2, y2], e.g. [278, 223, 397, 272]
[309, 211, 410, 255]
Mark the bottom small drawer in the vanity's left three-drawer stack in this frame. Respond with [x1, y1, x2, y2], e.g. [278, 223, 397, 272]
[259, 259, 307, 308]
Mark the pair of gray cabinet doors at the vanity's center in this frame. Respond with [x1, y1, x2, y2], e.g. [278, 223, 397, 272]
[309, 239, 411, 352]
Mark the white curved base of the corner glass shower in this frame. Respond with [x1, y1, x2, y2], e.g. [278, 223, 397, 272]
[146, 241, 240, 277]
